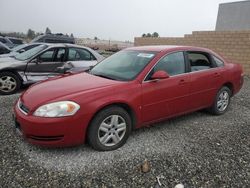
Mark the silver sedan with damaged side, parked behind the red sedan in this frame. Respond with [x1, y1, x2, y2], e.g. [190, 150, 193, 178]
[0, 44, 104, 95]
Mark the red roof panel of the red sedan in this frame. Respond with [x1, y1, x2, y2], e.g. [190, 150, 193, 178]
[125, 45, 212, 52]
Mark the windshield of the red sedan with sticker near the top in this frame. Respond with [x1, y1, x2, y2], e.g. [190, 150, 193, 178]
[90, 51, 156, 81]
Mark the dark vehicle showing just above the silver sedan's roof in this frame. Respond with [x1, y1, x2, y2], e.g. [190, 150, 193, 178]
[31, 33, 75, 44]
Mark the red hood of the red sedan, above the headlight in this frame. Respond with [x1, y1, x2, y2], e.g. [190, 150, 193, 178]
[21, 73, 123, 110]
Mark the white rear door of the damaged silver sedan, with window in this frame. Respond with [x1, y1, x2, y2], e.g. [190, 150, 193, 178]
[67, 47, 97, 70]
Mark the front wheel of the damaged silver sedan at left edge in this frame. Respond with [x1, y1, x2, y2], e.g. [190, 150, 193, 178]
[0, 72, 21, 95]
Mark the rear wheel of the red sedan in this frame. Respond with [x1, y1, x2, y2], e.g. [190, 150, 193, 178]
[209, 86, 232, 115]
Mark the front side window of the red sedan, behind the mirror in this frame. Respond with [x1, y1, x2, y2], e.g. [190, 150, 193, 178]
[153, 52, 185, 76]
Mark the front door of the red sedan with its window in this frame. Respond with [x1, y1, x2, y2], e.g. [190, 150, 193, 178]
[142, 52, 190, 122]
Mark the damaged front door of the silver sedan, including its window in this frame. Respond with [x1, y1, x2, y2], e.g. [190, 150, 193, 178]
[25, 48, 66, 81]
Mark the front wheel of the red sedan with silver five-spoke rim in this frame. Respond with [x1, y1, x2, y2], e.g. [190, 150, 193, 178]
[88, 106, 132, 151]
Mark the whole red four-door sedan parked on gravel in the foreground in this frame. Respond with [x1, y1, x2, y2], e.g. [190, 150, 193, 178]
[14, 46, 243, 151]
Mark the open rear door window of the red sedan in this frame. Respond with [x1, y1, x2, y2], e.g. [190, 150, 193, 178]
[188, 52, 213, 72]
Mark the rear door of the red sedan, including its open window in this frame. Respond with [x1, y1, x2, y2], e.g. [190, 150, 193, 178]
[186, 51, 221, 110]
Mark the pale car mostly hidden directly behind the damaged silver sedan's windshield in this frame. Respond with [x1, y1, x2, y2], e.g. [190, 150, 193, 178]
[0, 43, 44, 58]
